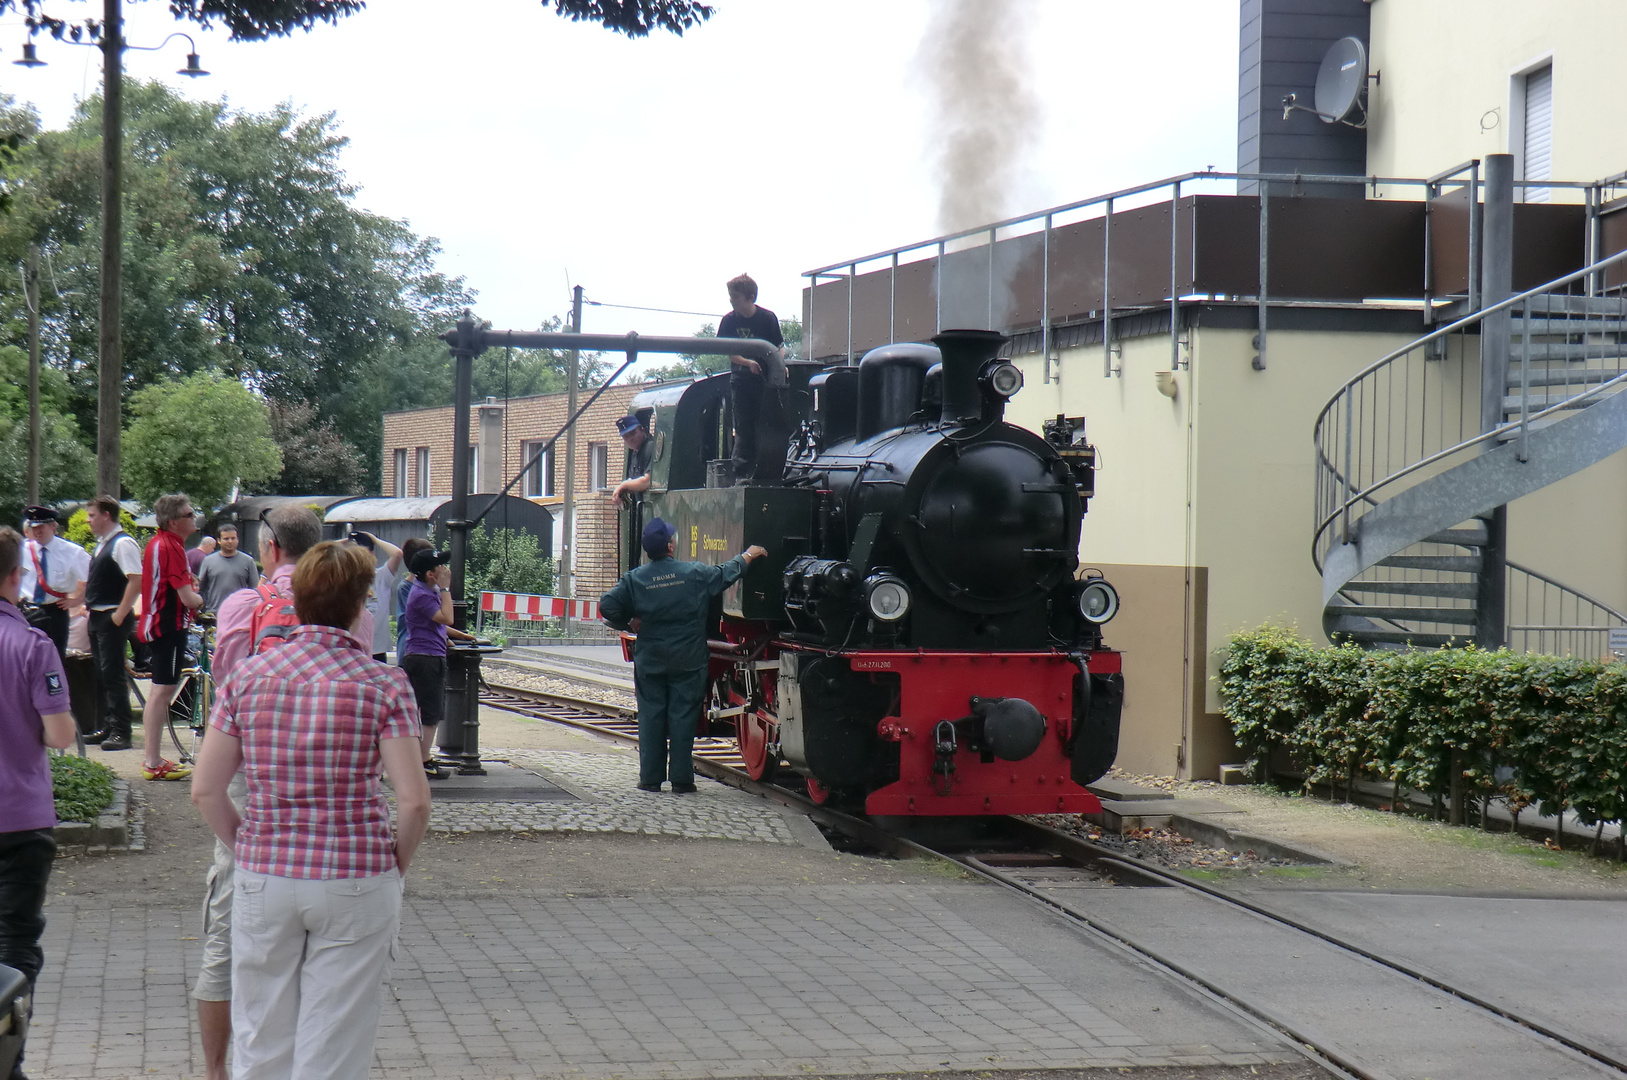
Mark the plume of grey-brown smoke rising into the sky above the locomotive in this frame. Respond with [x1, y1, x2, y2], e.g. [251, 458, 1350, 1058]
[914, 0, 1045, 233]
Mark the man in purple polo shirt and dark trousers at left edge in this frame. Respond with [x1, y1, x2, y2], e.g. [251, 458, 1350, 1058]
[0, 529, 73, 1080]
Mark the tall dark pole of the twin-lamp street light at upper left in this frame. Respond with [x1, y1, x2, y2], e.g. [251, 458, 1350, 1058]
[96, 0, 124, 499]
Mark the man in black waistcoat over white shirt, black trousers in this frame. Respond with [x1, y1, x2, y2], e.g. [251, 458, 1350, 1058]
[85, 494, 142, 750]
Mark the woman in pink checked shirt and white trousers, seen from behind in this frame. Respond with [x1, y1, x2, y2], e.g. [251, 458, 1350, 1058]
[192, 542, 430, 1080]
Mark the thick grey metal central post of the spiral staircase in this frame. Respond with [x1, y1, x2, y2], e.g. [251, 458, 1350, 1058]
[1474, 155, 1515, 649]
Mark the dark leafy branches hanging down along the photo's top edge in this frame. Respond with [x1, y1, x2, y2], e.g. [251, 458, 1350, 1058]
[9, 0, 713, 41]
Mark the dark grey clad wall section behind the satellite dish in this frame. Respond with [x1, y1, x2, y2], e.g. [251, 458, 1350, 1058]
[1237, 0, 1370, 197]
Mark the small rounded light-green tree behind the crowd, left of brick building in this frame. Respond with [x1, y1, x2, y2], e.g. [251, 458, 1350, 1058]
[124, 372, 283, 506]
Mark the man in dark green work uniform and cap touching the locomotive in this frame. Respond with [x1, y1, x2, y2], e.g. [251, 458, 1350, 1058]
[599, 517, 768, 795]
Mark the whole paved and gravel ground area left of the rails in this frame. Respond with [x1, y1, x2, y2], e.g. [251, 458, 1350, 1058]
[28, 709, 1298, 1080]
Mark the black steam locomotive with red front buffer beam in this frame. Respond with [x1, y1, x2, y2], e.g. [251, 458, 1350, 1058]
[623, 330, 1124, 817]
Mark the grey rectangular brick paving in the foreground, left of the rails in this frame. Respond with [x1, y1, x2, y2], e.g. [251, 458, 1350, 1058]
[29, 885, 1289, 1080]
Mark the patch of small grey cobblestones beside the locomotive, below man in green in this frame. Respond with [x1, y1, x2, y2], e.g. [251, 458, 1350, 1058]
[430, 750, 799, 844]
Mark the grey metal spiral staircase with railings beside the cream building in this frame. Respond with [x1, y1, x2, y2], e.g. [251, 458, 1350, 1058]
[1313, 252, 1627, 657]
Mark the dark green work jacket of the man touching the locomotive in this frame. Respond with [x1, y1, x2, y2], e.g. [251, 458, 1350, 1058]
[599, 555, 745, 675]
